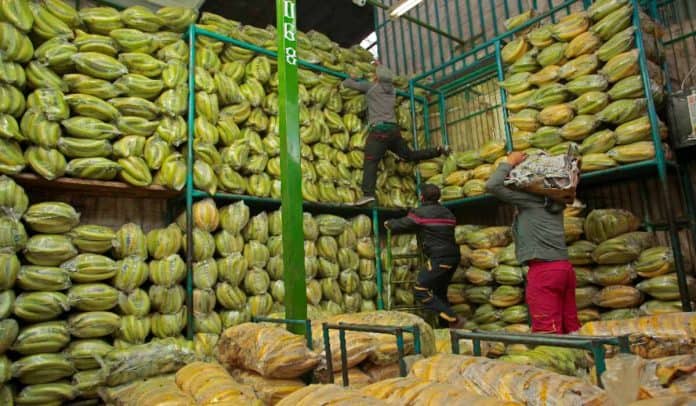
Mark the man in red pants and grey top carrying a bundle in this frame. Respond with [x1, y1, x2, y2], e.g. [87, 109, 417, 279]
[486, 152, 580, 334]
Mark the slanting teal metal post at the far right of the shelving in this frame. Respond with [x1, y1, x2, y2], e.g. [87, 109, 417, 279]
[631, 0, 691, 312]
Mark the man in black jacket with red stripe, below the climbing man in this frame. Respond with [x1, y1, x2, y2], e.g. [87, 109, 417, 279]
[384, 184, 461, 328]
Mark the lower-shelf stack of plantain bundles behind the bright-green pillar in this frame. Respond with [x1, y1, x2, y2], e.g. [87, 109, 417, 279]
[173, 199, 377, 334]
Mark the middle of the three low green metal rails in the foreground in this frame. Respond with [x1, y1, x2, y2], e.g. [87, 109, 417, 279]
[321, 323, 421, 386]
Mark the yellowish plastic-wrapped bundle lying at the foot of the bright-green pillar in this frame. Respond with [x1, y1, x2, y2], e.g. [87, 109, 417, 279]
[217, 323, 319, 378]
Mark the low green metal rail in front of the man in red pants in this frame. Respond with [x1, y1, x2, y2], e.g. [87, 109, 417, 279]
[450, 330, 631, 386]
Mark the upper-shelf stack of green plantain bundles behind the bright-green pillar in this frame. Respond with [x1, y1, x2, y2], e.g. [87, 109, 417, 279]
[188, 13, 422, 207]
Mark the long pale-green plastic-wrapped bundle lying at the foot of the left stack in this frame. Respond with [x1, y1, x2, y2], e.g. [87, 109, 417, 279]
[101, 339, 196, 386]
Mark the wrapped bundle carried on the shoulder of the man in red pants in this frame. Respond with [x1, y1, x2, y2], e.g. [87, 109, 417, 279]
[505, 145, 581, 204]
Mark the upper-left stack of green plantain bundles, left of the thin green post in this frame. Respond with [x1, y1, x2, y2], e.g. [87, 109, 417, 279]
[0, 0, 197, 190]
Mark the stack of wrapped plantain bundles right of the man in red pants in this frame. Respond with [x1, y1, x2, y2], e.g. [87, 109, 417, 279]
[565, 209, 694, 322]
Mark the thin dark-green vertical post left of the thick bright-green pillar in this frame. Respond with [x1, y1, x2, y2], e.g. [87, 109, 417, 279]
[186, 24, 196, 339]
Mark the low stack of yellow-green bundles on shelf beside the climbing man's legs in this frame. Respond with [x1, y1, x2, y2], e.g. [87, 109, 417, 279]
[418, 140, 506, 200]
